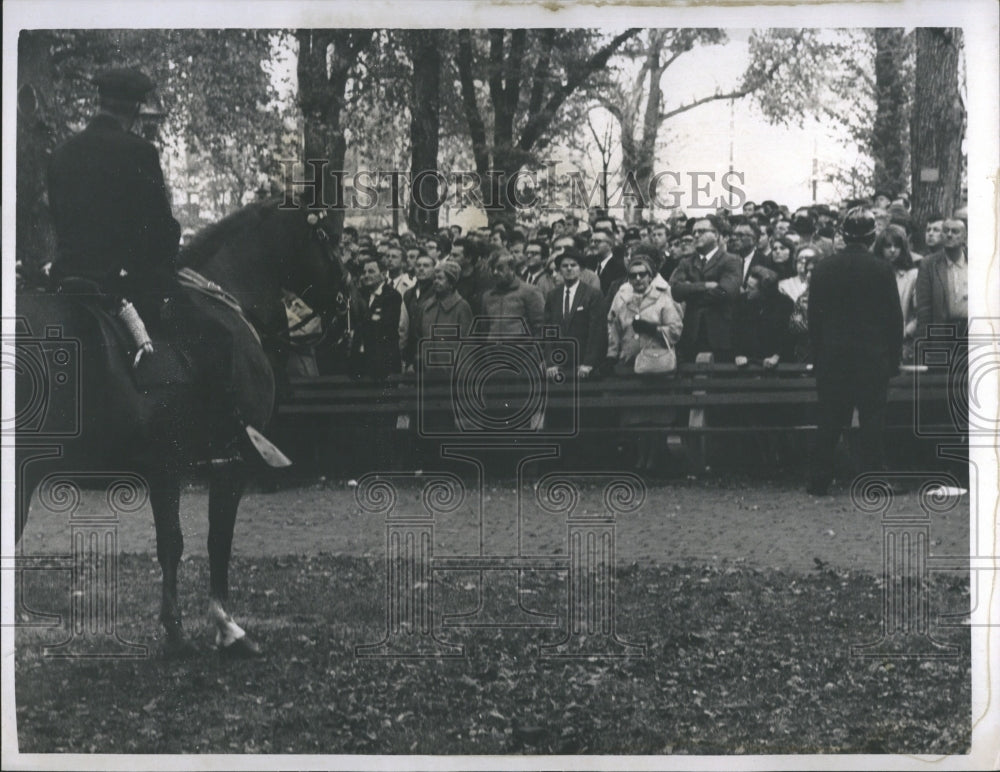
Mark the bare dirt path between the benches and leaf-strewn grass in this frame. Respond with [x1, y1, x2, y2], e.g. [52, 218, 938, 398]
[22, 474, 970, 572]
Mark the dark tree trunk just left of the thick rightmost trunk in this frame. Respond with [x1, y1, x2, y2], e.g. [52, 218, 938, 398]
[872, 27, 909, 195]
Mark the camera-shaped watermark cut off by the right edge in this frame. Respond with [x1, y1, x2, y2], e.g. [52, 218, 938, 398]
[913, 317, 1000, 439]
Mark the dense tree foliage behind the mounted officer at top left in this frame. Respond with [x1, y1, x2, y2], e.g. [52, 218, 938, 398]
[18, 29, 287, 266]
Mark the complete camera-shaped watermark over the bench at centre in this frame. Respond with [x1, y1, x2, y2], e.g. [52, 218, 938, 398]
[417, 317, 579, 440]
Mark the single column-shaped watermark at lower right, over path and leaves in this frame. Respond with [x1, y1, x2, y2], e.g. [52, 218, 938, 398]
[850, 472, 984, 659]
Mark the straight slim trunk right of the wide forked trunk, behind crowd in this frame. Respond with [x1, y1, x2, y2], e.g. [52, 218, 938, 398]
[407, 30, 442, 233]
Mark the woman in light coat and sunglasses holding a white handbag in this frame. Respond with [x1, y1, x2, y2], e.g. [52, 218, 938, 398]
[608, 254, 684, 470]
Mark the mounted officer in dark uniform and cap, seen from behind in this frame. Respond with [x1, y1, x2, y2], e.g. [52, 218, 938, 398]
[48, 69, 290, 466]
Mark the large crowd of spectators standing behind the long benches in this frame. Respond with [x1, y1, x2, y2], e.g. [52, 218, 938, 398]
[297, 193, 968, 379]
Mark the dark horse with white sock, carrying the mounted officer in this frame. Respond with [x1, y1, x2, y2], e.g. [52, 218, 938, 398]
[15, 201, 348, 656]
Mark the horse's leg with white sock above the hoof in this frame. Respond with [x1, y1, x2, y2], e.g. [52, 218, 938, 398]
[208, 464, 262, 658]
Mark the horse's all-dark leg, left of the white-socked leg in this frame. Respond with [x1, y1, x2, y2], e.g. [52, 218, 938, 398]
[148, 473, 196, 658]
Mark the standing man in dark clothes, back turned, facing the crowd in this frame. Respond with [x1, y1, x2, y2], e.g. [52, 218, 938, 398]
[807, 207, 903, 496]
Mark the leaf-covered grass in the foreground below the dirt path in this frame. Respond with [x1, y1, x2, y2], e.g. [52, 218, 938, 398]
[16, 554, 971, 754]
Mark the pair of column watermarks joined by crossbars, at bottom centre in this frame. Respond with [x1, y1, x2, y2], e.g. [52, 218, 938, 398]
[355, 473, 646, 659]
